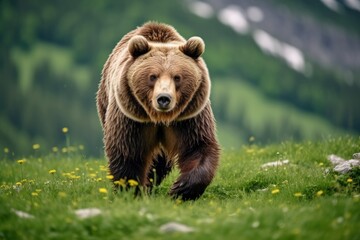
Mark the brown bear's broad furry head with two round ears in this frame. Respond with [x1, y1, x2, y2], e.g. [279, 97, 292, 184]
[118, 35, 210, 124]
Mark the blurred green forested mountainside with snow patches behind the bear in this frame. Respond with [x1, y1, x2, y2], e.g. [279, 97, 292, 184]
[0, 0, 360, 157]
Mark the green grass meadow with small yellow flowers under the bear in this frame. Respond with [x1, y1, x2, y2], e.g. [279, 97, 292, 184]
[0, 137, 360, 239]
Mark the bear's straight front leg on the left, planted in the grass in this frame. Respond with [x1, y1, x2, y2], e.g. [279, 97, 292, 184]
[104, 106, 154, 190]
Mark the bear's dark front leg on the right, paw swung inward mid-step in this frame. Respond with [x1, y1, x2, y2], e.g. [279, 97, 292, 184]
[170, 109, 220, 200]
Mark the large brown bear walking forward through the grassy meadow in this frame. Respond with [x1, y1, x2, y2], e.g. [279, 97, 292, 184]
[97, 22, 220, 200]
